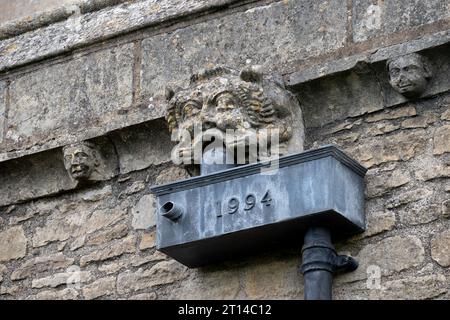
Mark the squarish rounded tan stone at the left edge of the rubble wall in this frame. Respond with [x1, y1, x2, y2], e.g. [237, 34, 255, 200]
[0, 226, 27, 262]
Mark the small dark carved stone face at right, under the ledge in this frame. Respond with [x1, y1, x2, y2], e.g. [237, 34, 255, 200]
[387, 53, 432, 98]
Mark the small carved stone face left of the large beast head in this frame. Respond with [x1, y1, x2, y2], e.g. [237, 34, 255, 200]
[63, 141, 100, 181]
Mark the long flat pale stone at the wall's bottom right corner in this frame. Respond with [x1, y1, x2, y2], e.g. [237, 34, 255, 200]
[368, 274, 448, 300]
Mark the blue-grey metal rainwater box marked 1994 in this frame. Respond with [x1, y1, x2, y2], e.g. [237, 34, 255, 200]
[151, 146, 366, 267]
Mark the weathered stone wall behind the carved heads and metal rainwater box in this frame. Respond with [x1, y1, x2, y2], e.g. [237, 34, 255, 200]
[0, 0, 450, 299]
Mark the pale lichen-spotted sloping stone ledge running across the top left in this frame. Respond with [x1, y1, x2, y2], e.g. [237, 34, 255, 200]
[0, 0, 243, 71]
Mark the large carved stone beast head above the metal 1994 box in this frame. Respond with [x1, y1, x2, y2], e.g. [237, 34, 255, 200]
[166, 66, 304, 170]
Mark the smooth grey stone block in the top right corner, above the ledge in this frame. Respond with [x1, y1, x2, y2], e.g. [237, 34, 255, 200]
[353, 0, 449, 42]
